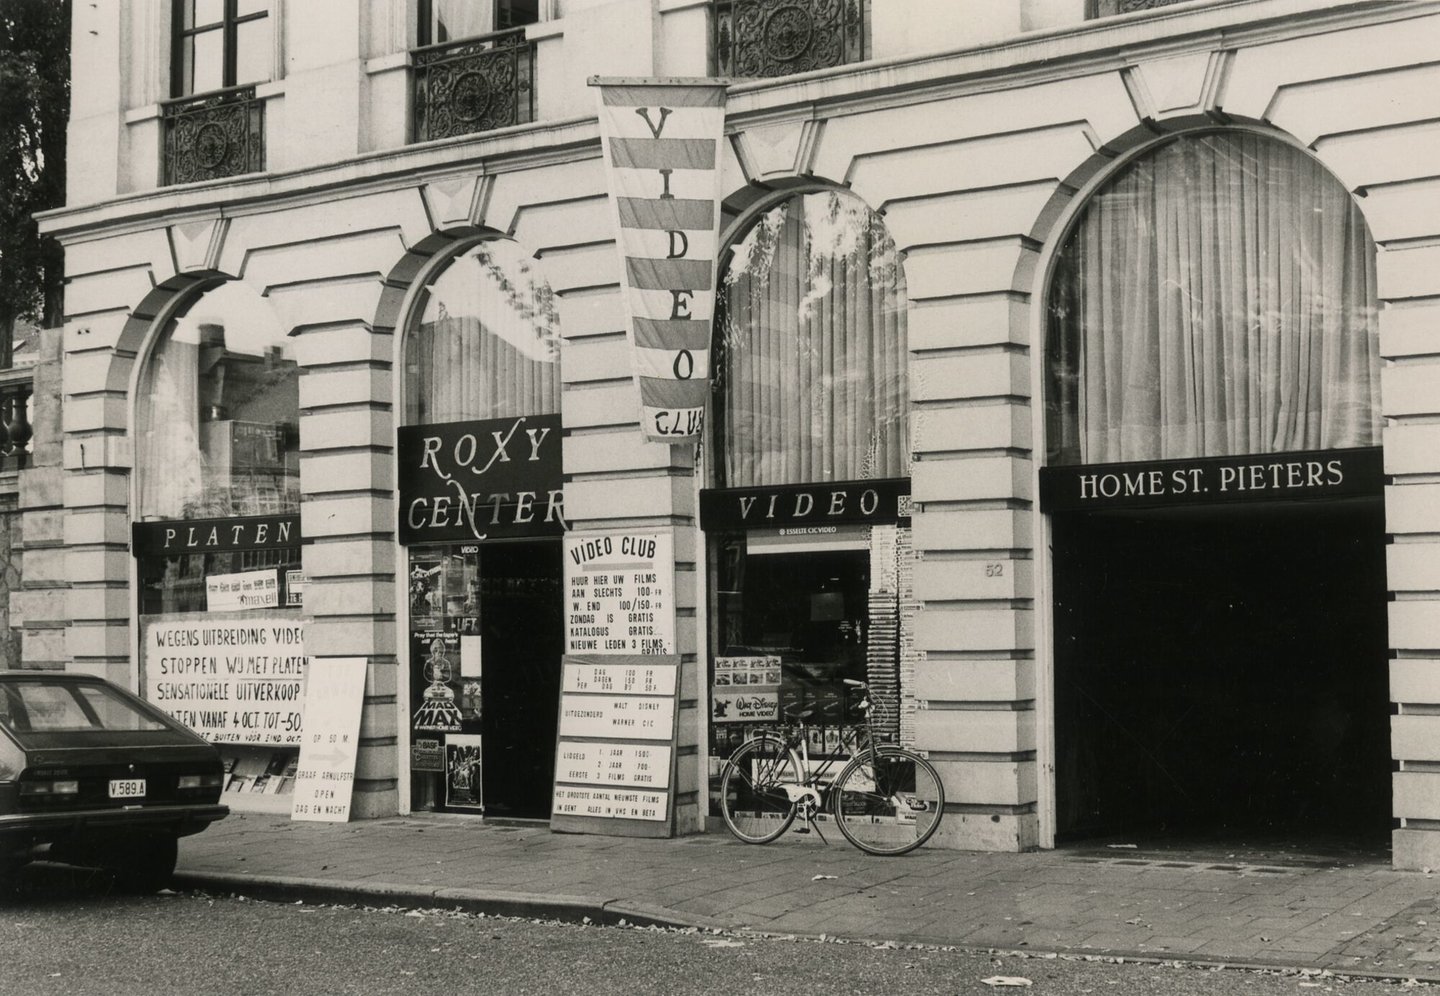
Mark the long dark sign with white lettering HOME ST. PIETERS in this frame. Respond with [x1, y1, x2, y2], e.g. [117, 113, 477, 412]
[1040, 446, 1385, 512]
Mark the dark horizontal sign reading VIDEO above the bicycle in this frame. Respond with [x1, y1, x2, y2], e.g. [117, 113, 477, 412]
[700, 478, 910, 530]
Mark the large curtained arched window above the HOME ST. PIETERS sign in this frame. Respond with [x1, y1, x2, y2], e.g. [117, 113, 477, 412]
[1045, 131, 1380, 465]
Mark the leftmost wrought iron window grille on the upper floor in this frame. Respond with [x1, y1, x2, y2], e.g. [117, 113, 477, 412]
[164, 86, 265, 186]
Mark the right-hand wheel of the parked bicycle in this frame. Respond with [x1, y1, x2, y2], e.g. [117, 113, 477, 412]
[831, 744, 945, 855]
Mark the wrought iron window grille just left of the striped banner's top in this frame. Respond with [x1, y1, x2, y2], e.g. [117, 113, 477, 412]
[410, 27, 536, 142]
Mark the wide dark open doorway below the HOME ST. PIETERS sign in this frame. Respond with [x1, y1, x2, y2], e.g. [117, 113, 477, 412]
[1051, 498, 1390, 842]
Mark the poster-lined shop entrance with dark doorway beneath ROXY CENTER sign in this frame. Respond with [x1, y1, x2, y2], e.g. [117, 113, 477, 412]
[409, 537, 564, 819]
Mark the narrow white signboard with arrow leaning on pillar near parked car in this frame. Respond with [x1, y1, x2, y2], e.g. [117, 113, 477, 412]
[289, 658, 366, 823]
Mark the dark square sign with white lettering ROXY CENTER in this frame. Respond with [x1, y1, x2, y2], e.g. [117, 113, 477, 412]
[397, 415, 566, 544]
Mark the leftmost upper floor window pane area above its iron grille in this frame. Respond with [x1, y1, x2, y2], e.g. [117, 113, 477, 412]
[171, 0, 275, 96]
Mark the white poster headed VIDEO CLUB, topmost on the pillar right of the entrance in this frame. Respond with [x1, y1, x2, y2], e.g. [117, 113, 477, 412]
[564, 533, 675, 655]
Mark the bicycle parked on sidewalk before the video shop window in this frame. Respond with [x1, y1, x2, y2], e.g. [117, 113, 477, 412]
[720, 678, 945, 855]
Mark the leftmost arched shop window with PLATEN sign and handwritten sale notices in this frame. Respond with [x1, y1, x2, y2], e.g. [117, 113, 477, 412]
[132, 281, 305, 812]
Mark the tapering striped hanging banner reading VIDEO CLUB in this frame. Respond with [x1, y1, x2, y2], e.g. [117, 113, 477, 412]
[590, 78, 726, 443]
